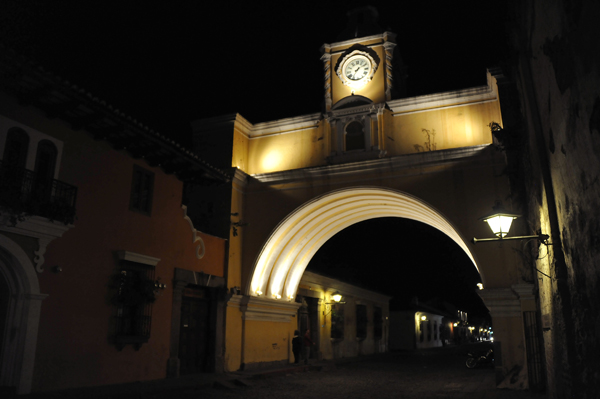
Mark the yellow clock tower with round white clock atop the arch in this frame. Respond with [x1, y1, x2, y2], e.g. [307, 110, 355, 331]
[321, 7, 404, 164]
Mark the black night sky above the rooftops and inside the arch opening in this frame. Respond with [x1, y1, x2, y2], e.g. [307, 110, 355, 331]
[0, 0, 506, 318]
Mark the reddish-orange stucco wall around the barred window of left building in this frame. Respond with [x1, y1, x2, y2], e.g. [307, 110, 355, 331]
[3, 98, 225, 391]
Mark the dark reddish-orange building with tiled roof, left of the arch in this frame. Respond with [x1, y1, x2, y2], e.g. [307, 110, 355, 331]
[0, 51, 228, 393]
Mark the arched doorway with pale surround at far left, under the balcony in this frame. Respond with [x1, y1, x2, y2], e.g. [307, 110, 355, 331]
[0, 235, 46, 394]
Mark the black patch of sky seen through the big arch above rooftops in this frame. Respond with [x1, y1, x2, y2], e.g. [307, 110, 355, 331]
[307, 217, 488, 318]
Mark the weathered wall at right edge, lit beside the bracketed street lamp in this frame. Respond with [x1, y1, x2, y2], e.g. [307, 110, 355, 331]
[496, 0, 600, 398]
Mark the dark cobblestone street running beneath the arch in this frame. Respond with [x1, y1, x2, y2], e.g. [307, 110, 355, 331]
[169, 349, 545, 399]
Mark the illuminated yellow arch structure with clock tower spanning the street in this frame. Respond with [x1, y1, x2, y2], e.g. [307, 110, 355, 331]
[192, 7, 535, 388]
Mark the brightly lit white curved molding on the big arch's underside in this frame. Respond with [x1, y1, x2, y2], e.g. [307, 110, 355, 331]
[246, 187, 485, 300]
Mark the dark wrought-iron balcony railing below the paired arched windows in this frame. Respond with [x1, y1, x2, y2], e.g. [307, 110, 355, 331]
[0, 160, 77, 224]
